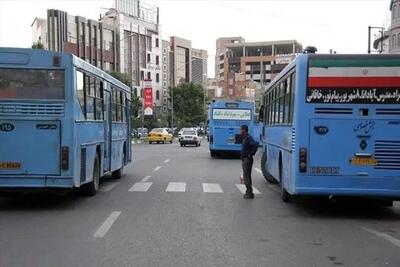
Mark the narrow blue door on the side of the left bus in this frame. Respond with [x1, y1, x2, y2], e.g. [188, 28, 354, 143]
[104, 87, 112, 171]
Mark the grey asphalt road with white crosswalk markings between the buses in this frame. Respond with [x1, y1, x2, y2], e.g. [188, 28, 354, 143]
[0, 142, 400, 267]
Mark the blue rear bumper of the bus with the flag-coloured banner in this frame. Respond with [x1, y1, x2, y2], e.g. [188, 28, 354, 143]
[294, 176, 400, 200]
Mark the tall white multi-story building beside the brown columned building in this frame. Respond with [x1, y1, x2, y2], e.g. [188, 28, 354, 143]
[100, 0, 163, 113]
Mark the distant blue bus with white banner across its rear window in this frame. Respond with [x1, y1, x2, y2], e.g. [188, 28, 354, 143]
[208, 100, 254, 157]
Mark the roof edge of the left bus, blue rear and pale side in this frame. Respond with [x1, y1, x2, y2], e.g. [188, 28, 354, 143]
[0, 47, 130, 93]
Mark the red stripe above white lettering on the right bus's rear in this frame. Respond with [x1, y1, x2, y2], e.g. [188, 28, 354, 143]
[308, 77, 400, 88]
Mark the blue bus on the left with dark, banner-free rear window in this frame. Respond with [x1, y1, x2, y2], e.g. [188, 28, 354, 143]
[0, 48, 131, 195]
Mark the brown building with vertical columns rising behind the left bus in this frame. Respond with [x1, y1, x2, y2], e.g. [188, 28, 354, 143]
[31, 9, 119, 71]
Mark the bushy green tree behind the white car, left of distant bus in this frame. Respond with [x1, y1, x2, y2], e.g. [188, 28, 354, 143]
[172, 83, 205, 128]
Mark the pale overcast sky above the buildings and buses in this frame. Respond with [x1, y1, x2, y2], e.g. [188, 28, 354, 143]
[0, 0, 390, 77]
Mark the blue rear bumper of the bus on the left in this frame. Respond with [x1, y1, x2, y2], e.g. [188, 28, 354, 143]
[0, 176, 74, 190]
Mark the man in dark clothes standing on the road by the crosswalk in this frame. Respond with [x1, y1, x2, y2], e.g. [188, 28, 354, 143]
[240, 125, 258, 199]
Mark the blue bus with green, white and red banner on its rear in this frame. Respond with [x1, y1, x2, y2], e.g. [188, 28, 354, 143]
[259, 54, 400, 203]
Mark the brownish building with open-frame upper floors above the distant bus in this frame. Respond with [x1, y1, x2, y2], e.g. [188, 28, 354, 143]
[216, 38, 303, 98]
